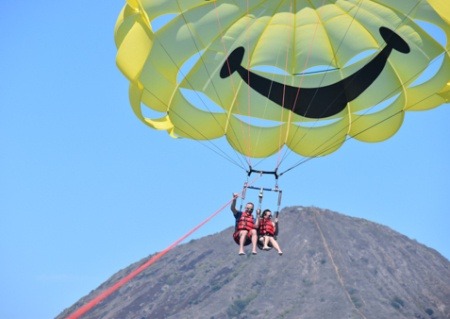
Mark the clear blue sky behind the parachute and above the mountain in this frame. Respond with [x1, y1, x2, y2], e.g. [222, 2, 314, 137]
[0, 0, 450, 319]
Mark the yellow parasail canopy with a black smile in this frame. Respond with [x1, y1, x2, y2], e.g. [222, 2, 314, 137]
[115, 0, 450, 157]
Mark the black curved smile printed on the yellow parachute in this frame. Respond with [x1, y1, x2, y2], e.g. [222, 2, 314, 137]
[220, 27, 410, 119]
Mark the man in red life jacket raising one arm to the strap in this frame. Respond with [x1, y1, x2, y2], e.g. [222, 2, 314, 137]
[231, 194, 259, 255]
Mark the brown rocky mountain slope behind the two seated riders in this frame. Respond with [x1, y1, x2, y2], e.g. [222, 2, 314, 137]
[57, 207, 450, 319]
